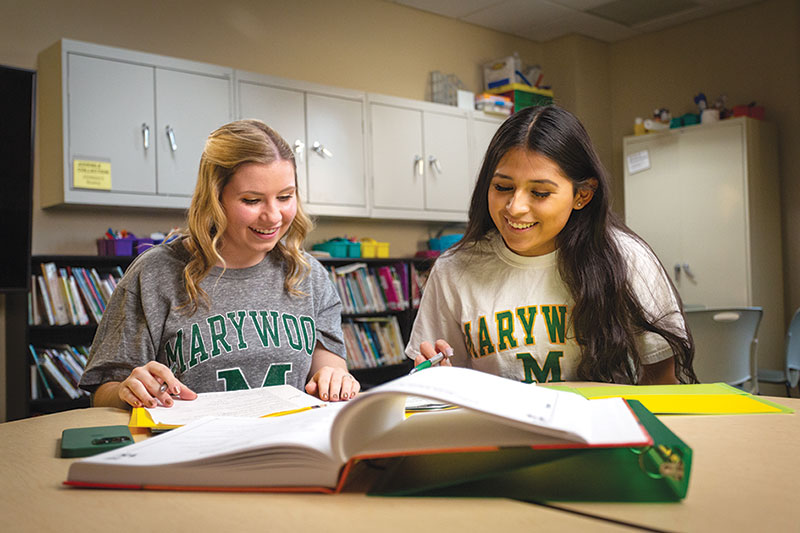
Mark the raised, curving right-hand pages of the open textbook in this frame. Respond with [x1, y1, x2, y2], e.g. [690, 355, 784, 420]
[332, 367, 650, 457]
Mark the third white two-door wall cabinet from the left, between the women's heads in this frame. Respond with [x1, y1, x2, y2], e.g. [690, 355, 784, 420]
[367, 94, 475, 221]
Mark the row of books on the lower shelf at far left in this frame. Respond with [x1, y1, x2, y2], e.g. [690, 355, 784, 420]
[28, 344, 89, 400]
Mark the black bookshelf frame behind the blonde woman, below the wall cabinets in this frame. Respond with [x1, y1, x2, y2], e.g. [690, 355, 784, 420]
[6, 255, 431, 420]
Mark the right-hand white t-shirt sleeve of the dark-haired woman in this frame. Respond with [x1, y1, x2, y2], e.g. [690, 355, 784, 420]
[628, 235, 686, 365]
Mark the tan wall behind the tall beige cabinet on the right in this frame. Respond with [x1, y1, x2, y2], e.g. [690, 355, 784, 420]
[598, 0, 800, 376]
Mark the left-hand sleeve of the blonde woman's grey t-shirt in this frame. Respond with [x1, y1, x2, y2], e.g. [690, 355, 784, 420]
[80, 283, 156, 392]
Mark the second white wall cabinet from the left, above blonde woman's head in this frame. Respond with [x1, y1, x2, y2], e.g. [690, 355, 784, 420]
[236, 71, 369, 216]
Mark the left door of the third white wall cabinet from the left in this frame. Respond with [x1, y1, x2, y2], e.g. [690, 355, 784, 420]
[370, 103, 425, 210]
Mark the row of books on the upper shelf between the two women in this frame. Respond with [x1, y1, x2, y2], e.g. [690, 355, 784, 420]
[325, 263, 422, 314]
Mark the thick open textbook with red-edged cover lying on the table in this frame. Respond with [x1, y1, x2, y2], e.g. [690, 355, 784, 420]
[66, 367, 688, 498]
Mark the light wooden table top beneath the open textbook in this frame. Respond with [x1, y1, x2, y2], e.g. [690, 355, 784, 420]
[0, 398, 800, 533]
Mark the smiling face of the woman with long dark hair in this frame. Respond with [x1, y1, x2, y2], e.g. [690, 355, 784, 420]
[488, 148, 588, 256]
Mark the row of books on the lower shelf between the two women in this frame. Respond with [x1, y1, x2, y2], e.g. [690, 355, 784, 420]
[342, 316, 405, 368]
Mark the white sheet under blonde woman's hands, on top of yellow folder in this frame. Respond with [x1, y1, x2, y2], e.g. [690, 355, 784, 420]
[147, 385, 325, 426]
